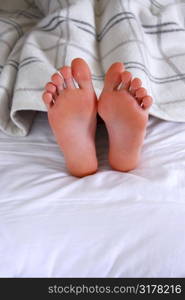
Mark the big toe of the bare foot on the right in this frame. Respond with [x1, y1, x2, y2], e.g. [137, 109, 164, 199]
[104, 62, 124, 92]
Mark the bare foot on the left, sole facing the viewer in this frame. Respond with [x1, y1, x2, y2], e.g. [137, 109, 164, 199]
[43, 59, 97, 177]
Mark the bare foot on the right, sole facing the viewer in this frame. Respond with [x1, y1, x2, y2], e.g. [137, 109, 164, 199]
[98, 63, 152, 172]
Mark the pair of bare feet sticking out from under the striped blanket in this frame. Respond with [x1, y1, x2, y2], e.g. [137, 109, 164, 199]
[43, 58, 152, 177]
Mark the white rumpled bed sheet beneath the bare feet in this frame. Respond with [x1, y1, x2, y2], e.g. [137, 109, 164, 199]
[0, 113, 185, 277]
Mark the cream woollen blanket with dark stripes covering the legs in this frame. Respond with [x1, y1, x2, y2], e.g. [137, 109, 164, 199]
[0, 0, 185, 136]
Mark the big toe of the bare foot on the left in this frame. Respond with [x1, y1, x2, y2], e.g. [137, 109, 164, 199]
[72, 58, 93, 89]
